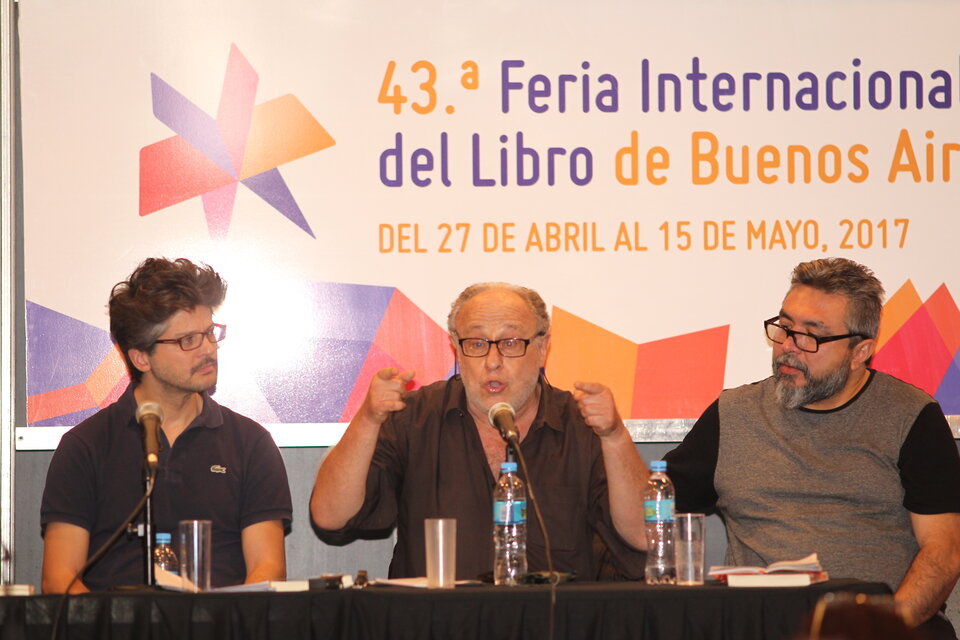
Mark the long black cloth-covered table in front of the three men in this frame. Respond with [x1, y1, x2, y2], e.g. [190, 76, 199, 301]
[0, 580, 890, 640]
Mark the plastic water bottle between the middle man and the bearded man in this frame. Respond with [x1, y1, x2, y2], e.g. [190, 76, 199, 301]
[643, 460, 677, 584]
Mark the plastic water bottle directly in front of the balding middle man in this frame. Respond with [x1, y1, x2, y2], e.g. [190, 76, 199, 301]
[493, 462, 527, 585]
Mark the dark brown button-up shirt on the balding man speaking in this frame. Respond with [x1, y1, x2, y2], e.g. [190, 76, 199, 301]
[326, 376, 644, 580]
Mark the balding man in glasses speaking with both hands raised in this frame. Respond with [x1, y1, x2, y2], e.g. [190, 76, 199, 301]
[310, 283, 647, 580]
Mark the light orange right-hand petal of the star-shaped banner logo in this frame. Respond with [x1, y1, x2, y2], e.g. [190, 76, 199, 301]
[240, 94, 336, 180]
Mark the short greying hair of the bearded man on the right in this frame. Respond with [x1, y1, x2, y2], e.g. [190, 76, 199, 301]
[790, 258, 883, 346]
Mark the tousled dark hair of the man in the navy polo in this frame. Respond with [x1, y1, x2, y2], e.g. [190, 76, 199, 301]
[108, 258, 227, 382]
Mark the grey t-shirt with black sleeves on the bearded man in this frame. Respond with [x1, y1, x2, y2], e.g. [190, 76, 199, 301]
[667, 372, 960, 589]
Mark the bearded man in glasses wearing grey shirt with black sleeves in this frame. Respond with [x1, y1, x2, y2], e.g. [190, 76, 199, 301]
[666, 258, 960, 638]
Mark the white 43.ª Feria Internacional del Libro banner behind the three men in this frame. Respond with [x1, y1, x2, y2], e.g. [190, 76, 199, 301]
[18, 0, 960, 428]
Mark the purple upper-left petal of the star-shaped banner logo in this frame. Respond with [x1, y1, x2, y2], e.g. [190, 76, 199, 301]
[150, 73, 238, 178]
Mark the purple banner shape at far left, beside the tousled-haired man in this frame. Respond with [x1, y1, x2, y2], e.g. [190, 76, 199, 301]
[26, 300, 113, 396]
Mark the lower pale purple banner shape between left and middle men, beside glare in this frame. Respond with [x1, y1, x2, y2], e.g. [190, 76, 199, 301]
[257, 339, 370, 423]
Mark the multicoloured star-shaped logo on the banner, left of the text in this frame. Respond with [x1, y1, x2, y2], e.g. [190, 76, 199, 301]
[140, 45, 336, 239]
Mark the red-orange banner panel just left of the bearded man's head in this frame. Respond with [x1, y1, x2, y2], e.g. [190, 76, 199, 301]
[631, 325, 730, 419]
